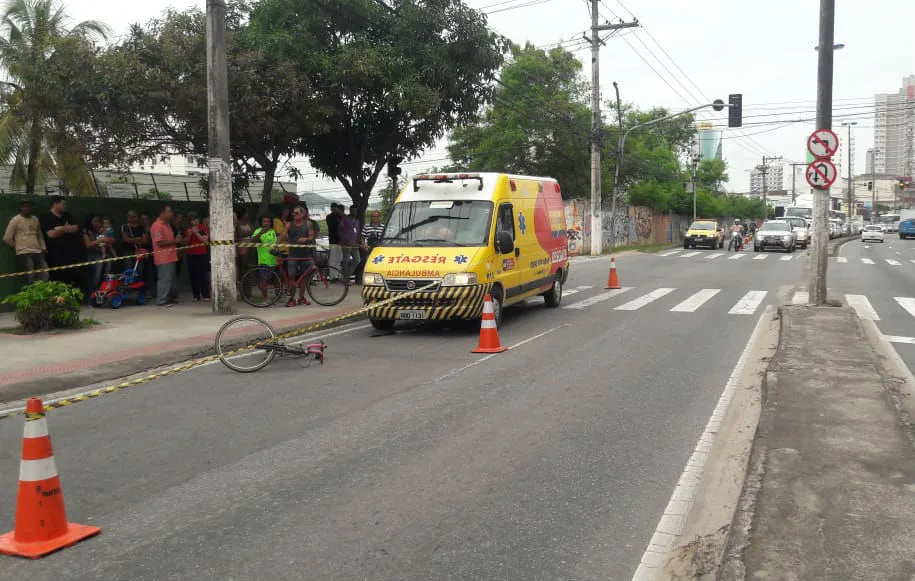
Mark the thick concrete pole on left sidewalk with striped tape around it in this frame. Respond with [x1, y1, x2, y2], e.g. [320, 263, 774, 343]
[207, 0, 238, 315]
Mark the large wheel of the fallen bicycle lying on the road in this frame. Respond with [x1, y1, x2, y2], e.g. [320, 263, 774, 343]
[216, 316, 277, 373]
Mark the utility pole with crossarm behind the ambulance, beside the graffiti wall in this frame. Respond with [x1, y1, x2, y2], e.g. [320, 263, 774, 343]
[585, 7, 639, 256]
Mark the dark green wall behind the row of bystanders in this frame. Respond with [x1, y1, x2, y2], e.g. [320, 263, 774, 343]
[0, 194, 292, 311]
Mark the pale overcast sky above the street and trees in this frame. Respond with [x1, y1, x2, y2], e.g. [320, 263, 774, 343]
[68, 0, 915, 198]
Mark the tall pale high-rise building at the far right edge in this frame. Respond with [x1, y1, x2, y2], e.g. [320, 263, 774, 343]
[873, 75, 915, 177]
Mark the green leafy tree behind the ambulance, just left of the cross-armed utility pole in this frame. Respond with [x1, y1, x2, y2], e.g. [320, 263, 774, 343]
[448, 44, 592, 197]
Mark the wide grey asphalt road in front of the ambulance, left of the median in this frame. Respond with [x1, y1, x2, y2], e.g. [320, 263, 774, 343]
[0, 245, 808, 581]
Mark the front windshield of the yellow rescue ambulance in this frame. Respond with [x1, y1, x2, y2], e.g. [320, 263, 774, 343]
[381, 200, 492, 246]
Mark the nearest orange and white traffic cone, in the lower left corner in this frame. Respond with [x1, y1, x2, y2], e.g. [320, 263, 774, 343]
[0, 397, 102, 559]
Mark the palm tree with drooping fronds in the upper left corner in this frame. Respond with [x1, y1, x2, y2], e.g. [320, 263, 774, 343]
[0, 0, 109, 194]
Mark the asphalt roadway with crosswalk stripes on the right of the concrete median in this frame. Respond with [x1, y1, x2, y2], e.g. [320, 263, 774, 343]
[826, 233, 915, 370]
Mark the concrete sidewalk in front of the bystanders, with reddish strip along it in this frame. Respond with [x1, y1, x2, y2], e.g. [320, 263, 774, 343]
[0, 285, 362, 403]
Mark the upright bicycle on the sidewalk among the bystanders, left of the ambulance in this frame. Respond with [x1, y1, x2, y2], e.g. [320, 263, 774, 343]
[241, 256, 349, 307]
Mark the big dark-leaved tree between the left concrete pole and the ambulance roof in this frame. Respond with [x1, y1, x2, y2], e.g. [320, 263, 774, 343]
[251, 0, 504, 221]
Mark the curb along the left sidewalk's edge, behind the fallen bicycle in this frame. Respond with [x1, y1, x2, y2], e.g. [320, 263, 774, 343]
[0, 309, 367, 404]
